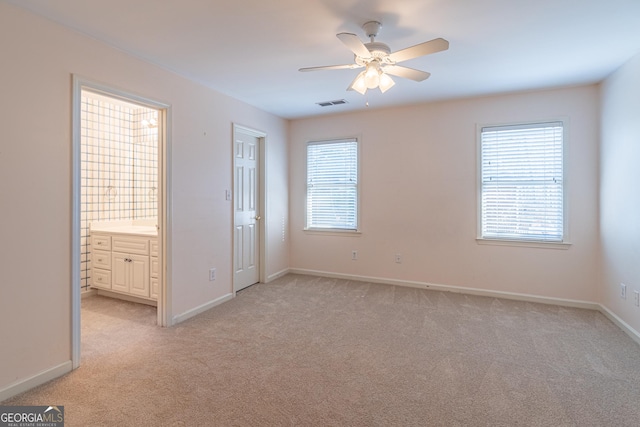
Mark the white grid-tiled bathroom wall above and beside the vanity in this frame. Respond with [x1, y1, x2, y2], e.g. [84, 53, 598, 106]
[80, 91, 158, 290]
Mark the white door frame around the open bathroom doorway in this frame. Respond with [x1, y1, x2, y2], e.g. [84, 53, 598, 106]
[71, 74, 173, 369]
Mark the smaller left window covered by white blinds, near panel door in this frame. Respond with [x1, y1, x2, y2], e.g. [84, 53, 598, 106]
[306, 139, 358, 231]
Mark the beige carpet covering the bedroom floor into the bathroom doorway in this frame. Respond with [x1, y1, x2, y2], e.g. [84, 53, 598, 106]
[3, 275, 640, 427]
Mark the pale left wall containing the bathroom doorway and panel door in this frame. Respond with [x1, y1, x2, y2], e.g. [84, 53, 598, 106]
[0, 3, 289, 391]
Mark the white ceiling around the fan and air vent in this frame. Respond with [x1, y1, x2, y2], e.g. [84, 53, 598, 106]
[5, 0, 640, 118]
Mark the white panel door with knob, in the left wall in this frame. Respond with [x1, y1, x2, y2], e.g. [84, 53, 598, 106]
[233, 128, 261, 291]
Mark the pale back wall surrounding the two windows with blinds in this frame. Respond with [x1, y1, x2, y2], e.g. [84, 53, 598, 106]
[289, 86, 599, 302]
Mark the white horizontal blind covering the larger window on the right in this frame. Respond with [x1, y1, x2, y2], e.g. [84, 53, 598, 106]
[480, 122, 564, 242]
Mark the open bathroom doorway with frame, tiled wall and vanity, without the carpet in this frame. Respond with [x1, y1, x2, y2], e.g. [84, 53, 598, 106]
[72, 78, 169, 369]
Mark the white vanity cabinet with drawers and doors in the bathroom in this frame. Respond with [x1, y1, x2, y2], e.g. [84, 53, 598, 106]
[91, 232, 158, 301]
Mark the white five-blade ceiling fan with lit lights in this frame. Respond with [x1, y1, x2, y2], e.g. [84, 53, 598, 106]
[299, 21, 449, 95]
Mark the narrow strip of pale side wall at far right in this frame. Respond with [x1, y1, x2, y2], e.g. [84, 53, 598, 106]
[600, 54, 640, 331]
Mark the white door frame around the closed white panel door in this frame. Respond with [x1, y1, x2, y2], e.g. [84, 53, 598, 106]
[231, 123, 268, 296]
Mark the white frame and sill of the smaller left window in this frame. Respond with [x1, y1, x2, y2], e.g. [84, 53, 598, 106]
[303, 136, 362, 236]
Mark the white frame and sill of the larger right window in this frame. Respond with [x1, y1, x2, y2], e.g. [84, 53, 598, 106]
[476, 117, 571, 249]
